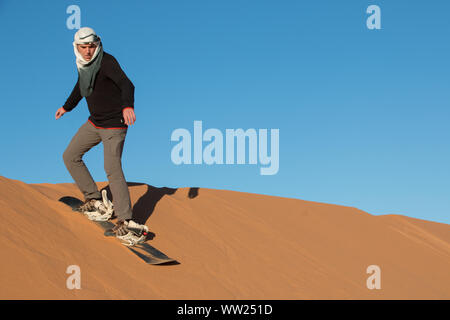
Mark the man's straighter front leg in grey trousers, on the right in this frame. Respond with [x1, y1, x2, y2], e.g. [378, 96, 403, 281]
[100, 129, 132, 220]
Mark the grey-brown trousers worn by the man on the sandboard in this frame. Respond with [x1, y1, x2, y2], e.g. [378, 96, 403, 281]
[63, 121, 132, 220]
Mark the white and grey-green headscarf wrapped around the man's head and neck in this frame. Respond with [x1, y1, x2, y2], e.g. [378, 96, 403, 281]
[73, 27, 103, 97]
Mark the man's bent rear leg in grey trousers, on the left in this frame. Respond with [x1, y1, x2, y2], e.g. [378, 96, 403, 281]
[63, 122, 102, 200]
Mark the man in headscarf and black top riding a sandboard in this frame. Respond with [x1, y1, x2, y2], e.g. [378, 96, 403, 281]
[55, 27, 148, 243]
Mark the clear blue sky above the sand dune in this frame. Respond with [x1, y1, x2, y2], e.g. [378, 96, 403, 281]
[0, 0, 450, 223]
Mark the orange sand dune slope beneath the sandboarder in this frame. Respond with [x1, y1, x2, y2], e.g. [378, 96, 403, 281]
[0, 176, 450, 299]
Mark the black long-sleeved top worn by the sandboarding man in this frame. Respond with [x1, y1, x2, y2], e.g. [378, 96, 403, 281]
[63, 51, 134, 128]
